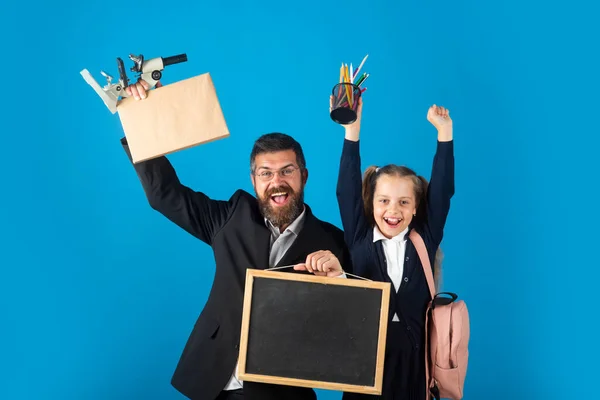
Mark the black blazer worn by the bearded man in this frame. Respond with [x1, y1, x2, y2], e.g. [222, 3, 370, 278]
[121, 138, 352, 400]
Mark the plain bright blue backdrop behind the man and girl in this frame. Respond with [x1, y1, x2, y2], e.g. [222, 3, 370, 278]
[0, 0, 600, 400]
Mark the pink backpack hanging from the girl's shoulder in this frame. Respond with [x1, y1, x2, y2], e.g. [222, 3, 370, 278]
[410, 229, 470, 400]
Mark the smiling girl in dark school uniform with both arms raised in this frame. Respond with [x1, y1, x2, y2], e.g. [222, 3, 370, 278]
[337, 99, 454, 400]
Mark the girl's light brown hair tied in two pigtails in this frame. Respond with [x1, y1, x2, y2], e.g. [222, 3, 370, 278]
[362, 164, 444, 292]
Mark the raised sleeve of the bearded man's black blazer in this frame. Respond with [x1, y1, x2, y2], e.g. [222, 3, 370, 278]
[121, 138, 235, 245]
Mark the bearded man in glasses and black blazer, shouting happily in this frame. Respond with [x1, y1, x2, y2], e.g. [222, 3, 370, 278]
[121, 81, 351, 400]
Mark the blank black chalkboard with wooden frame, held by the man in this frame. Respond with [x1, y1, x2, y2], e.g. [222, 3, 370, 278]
[239, 269, 390, 394]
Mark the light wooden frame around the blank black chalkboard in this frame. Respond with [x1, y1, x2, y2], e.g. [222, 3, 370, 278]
[238, 269, 391, 395]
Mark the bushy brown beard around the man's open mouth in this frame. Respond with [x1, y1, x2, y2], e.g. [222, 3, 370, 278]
[255, 186, 304, 228]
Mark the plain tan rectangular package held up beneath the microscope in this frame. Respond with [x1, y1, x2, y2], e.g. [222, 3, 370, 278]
[117, 73, 229, 163]
